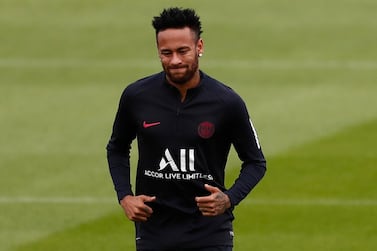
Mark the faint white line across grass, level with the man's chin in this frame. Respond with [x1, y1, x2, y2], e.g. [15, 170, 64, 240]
[0, 58, 377, 70]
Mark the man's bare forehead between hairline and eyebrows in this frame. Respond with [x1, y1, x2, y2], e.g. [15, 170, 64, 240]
[157, 27, 196, 49]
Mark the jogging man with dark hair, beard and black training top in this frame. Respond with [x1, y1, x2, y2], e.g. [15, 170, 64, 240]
[107, 8, 266, 251]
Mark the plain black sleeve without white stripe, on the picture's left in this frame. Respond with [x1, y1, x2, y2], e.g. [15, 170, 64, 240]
[106, 89, 136, 201]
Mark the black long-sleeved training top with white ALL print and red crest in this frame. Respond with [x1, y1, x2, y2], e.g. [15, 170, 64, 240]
[107, 72, 266, 249]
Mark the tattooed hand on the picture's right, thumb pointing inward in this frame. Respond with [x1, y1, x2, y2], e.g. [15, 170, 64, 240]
[195, 184, 231, 216]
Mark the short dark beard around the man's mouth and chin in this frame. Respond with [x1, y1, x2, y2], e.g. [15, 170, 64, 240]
[162, 60, 199, 85]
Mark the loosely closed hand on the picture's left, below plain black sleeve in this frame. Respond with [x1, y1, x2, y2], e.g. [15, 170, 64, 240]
[120, 195, 156, 221]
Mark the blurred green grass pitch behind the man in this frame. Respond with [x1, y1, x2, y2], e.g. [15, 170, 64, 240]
[0, 0, 377, 251]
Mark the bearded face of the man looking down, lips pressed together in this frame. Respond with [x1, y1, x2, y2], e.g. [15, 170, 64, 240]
[157, 27, 203, 85]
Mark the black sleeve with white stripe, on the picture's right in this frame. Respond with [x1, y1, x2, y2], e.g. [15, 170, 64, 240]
[225, 99, 266, 206]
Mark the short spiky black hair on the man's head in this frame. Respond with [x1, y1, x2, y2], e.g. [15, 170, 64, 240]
[152, 7, 203, 39]
